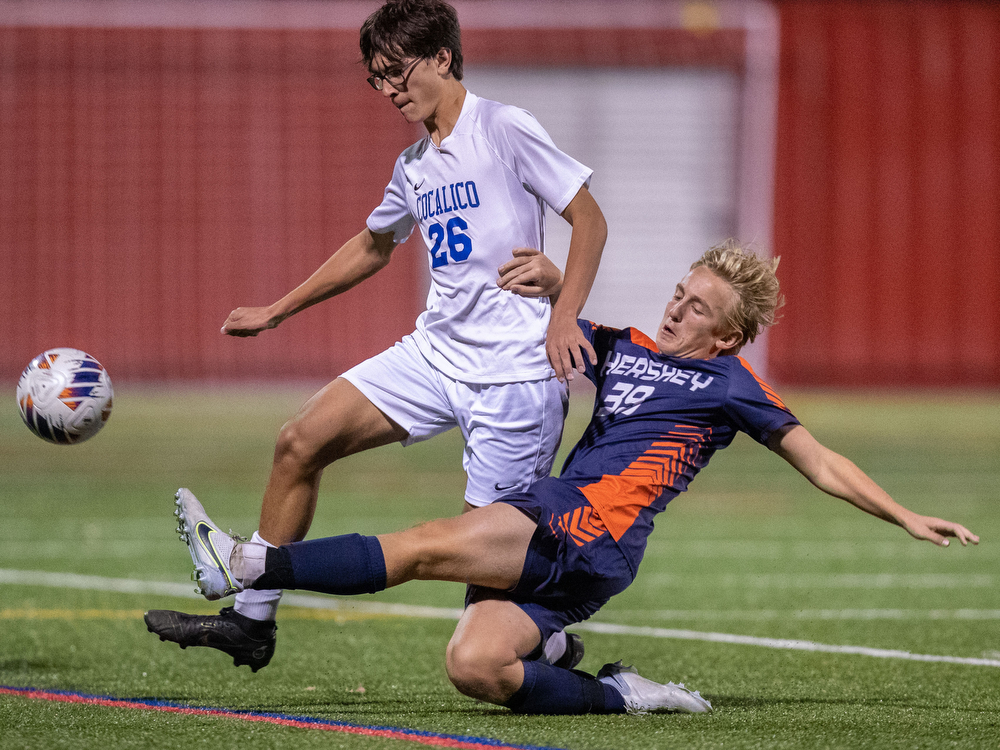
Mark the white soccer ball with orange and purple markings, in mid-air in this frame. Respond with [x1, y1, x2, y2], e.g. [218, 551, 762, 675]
[17, 348, 114, 445]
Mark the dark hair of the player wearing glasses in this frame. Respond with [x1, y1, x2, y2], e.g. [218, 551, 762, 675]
[361, 0, 462, 81]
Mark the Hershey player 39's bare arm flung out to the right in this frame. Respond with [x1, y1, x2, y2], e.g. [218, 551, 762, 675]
[768, 425, 979, 547]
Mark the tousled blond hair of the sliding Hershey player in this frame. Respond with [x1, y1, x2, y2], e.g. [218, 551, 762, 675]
[691, 239, 785, 354]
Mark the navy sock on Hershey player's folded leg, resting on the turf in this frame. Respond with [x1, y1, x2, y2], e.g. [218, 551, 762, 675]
[506, 661, 625, 714]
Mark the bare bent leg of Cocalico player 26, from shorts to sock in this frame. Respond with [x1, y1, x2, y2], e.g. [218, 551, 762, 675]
[259, 378, 406, 545]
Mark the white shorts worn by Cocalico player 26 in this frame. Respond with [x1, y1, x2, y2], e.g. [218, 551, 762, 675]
[341, 336, 569, 506]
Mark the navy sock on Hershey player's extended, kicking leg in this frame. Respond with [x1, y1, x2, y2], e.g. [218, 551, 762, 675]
[252, 534, 386, 594]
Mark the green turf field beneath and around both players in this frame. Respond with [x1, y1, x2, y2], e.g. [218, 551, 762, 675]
[0, 388, 1000, 750]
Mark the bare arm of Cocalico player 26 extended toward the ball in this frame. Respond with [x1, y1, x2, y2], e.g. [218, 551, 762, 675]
[222, 229, 396, 336]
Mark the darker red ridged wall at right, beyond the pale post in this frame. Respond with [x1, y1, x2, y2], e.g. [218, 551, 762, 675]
[769, 1, 1000, 386]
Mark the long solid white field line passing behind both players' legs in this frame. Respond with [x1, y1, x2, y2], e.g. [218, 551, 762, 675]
[0, 568, 1000, 667]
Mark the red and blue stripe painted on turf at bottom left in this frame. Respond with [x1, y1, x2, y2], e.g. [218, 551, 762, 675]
[0, 685, 561, 750]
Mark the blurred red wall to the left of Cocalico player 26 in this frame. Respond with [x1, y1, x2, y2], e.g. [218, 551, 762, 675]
[0, 28, 426, 379]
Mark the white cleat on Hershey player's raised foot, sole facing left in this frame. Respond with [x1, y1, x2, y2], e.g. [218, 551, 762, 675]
[174, 487, 243, 601]
